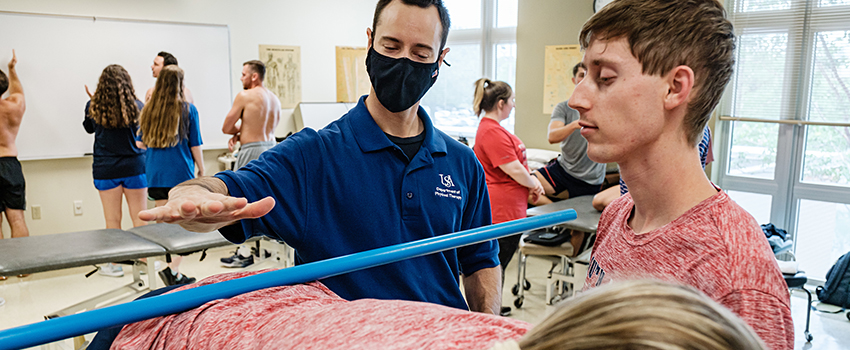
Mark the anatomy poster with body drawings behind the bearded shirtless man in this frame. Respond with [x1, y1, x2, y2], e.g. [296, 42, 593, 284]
[260, 45, 301, 108]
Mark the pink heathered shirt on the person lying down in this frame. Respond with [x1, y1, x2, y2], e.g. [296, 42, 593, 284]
[111, 271, 531, 349]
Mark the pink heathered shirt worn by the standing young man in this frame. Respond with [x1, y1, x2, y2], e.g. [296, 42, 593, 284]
[584, 191, 794, 350]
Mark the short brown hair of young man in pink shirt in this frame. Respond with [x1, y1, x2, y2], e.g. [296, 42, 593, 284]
[579, 0, 735, 146]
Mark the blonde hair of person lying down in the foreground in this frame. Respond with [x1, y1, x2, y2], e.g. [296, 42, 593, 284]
[492, 280, 765, 350]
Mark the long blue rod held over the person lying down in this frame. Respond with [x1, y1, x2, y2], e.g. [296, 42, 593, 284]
[0, 209, 576, 349]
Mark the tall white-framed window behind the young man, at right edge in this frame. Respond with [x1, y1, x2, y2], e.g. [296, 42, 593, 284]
[718, 0, 850, 280]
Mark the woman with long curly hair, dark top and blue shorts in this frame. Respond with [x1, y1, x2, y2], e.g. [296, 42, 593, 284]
[83, 64, 148, 277]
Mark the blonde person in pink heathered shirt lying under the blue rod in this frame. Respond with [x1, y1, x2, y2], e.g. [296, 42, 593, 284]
[107, 271, 764, 350]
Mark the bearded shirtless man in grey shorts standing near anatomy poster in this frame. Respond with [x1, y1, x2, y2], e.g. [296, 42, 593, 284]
[221, 60, 280, 169]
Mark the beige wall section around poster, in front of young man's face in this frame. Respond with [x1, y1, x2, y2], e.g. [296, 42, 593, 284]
[514, 0, 593, 151]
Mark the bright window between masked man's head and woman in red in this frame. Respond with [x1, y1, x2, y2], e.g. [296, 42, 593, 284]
[421, 0, 518, 138]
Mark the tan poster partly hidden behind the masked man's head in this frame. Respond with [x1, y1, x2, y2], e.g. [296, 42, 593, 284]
[336, 46, 372, 102]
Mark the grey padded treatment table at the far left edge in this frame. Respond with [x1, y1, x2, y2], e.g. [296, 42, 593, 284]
[0, 229, 165, 318]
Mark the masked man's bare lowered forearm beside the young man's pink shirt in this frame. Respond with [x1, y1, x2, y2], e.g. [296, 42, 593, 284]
[463, 266, 502, 315]
